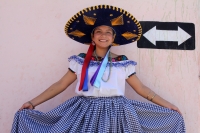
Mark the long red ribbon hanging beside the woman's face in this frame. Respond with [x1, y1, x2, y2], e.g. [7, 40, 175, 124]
[79, 43, 94, 91]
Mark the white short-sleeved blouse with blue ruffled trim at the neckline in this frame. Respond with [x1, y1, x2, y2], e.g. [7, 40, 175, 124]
[69, 55, 137, 97]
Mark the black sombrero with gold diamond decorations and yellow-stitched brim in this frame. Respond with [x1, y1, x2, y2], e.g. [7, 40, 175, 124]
[65, 5, 142, 45]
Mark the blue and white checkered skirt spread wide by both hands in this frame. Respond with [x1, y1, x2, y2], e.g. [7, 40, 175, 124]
[11, 96, 185, 133]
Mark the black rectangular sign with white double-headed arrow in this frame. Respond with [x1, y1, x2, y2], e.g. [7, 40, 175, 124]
[137, 21, 195, 50]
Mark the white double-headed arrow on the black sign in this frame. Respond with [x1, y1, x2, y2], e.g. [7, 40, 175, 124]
[143, 26, 191, 45]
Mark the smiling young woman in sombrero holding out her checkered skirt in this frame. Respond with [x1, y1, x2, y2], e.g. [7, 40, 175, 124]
[11, 5, 185, 133]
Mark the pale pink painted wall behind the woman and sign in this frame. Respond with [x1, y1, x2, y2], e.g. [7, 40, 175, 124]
[0, 0, 200, 133]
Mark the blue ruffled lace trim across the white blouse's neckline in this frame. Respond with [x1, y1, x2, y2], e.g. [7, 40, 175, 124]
[68, 55, 137, 67]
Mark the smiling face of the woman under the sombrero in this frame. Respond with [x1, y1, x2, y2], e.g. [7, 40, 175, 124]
[92, 25, 114, 48]
